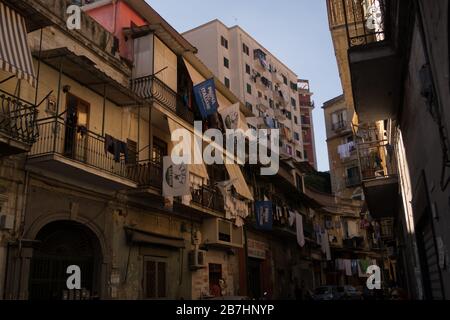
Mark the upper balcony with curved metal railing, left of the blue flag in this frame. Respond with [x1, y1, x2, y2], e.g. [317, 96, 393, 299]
[130, 76, 194, 123]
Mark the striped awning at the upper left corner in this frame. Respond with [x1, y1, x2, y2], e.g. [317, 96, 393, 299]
[0, 2, 36, 87]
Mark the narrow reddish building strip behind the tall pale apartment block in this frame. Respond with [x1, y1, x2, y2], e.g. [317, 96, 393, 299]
[298, 79, 317, 170]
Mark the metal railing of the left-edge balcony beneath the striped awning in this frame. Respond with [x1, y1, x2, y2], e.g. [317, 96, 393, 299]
[0, 90, 39, 145]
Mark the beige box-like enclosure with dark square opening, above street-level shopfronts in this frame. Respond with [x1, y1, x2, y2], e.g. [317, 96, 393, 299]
[202, 218, 244, 248]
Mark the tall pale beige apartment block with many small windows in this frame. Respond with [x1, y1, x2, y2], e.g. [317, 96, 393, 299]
[183, 20, 305, 161]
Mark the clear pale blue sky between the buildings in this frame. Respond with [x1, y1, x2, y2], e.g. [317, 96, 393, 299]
[146, 0, 342, 171]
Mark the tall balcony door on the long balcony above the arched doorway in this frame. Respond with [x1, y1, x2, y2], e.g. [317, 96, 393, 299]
[64, 93, 90, 162]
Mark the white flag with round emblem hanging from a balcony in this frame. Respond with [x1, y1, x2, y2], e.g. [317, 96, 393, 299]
[163, 157, 190, 197]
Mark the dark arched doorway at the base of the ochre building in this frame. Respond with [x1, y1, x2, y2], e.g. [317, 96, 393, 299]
[29, 221, 102, 300]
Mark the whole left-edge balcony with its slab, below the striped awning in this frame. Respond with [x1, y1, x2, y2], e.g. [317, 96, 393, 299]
[0, 90, 39, 156]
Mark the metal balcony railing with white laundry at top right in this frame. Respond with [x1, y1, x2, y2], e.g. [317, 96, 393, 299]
[342, 0, 387, 48]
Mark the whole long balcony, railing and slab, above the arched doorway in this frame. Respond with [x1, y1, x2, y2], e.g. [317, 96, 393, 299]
[27, 118, 162, 190]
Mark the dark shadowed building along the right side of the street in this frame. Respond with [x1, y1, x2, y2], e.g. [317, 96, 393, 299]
[328, 0, 450, 300]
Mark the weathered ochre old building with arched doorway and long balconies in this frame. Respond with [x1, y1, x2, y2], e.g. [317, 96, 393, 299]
[0, 0, 252, 300]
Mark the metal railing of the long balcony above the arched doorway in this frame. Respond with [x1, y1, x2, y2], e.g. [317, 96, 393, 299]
[29, 117, 162, 189]
